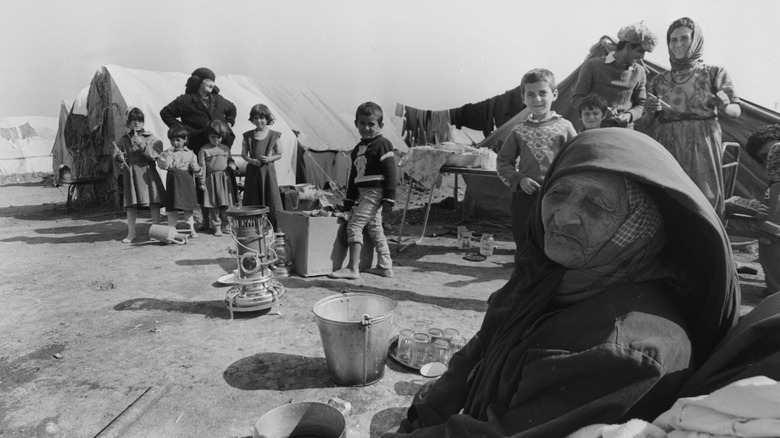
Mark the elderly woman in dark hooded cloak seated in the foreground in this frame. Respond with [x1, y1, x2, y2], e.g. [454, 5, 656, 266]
[386, 128, 740, 437]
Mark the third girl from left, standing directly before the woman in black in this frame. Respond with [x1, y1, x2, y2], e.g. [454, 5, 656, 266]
[198, 120, 236, 237]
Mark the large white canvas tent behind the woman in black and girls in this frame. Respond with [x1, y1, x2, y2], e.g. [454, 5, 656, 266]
[53, 65, 407, 207]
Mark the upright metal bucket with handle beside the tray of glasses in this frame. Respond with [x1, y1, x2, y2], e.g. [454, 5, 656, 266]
[313, 292, 398, 386]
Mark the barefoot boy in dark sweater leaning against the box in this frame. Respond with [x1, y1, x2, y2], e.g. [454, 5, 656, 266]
[330, 102, 397, 280]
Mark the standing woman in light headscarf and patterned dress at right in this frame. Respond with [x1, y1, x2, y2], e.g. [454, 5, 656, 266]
[643, 17, 741, 218]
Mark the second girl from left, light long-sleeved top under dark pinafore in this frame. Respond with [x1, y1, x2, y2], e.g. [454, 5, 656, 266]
[157, 125, 201, 238]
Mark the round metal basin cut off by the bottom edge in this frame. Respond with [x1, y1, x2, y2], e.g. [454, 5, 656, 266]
[252, 402, 347, 438]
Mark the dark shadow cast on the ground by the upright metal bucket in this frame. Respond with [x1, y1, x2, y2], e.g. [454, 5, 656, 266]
[222, 353, 336, 391]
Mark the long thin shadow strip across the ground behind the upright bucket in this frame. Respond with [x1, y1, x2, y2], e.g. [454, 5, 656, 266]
[282, 276, 488, 312]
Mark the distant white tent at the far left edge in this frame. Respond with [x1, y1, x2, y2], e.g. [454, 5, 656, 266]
[0, 116, 58, 175]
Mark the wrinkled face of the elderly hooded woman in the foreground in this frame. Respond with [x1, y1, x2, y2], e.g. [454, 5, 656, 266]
[542, 172, 628, 269]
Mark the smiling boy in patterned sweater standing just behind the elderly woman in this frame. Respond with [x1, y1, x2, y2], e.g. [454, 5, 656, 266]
[496, 68, 577, 254]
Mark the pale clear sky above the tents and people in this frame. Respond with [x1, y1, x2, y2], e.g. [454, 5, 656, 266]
[0, 0, 780, 117]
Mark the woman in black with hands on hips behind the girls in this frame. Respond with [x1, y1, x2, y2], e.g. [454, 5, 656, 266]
[160, 67, 236, 230]
